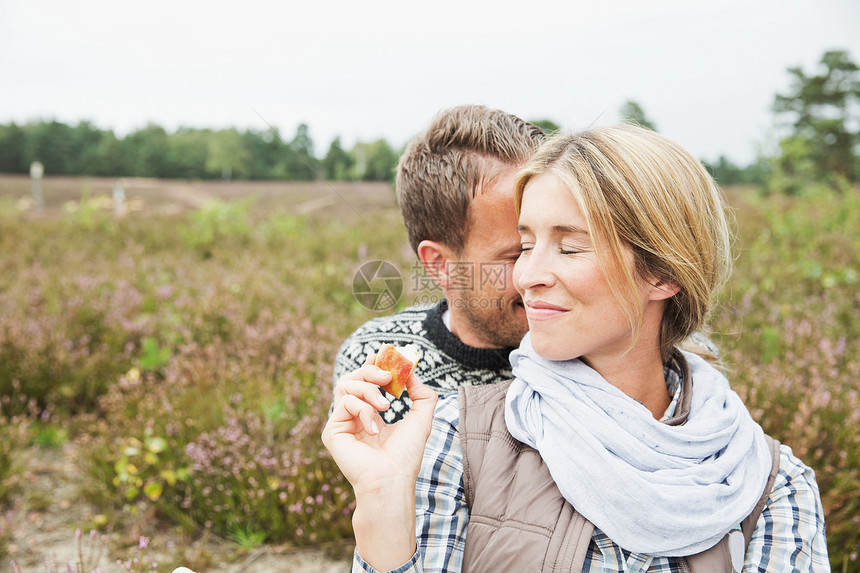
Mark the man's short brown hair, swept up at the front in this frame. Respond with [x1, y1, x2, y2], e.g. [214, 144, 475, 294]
[397, 105, 544, 253]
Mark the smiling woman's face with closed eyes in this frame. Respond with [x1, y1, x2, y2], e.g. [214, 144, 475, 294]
[513, 173, 662, 371]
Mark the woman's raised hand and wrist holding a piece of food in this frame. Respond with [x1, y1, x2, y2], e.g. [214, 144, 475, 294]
[322, 355, 437, 571]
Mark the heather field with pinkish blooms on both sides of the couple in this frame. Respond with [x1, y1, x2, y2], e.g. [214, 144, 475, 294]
[0, 176, 860, 571]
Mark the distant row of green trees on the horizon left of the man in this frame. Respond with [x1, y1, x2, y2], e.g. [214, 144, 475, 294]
[0, 121, 399, 181]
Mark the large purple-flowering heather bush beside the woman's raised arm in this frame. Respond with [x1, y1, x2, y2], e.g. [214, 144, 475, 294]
[86, 302, 352, 544]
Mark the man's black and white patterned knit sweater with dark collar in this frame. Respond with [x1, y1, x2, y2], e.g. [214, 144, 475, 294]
[334, 299, 513, 424]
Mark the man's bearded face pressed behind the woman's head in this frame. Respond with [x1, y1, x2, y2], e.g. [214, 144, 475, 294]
[446, 168, 528, 348]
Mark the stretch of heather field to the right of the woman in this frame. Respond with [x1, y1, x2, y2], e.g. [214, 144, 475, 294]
[714, 184, 860, 570]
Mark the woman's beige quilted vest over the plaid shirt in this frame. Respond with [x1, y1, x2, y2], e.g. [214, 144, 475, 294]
[459, 375, 779, 573]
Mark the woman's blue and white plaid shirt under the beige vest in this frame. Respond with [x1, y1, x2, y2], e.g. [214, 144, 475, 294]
[352, 369, 830, 573]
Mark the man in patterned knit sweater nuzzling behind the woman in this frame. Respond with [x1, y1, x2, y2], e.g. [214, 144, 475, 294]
[334, 105, 544, 423]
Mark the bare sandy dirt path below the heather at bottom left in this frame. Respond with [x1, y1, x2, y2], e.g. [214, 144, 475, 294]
[5, 444, 350, 573]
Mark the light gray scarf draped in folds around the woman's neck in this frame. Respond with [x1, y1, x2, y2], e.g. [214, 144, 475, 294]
[505, 335, 771, 556]
